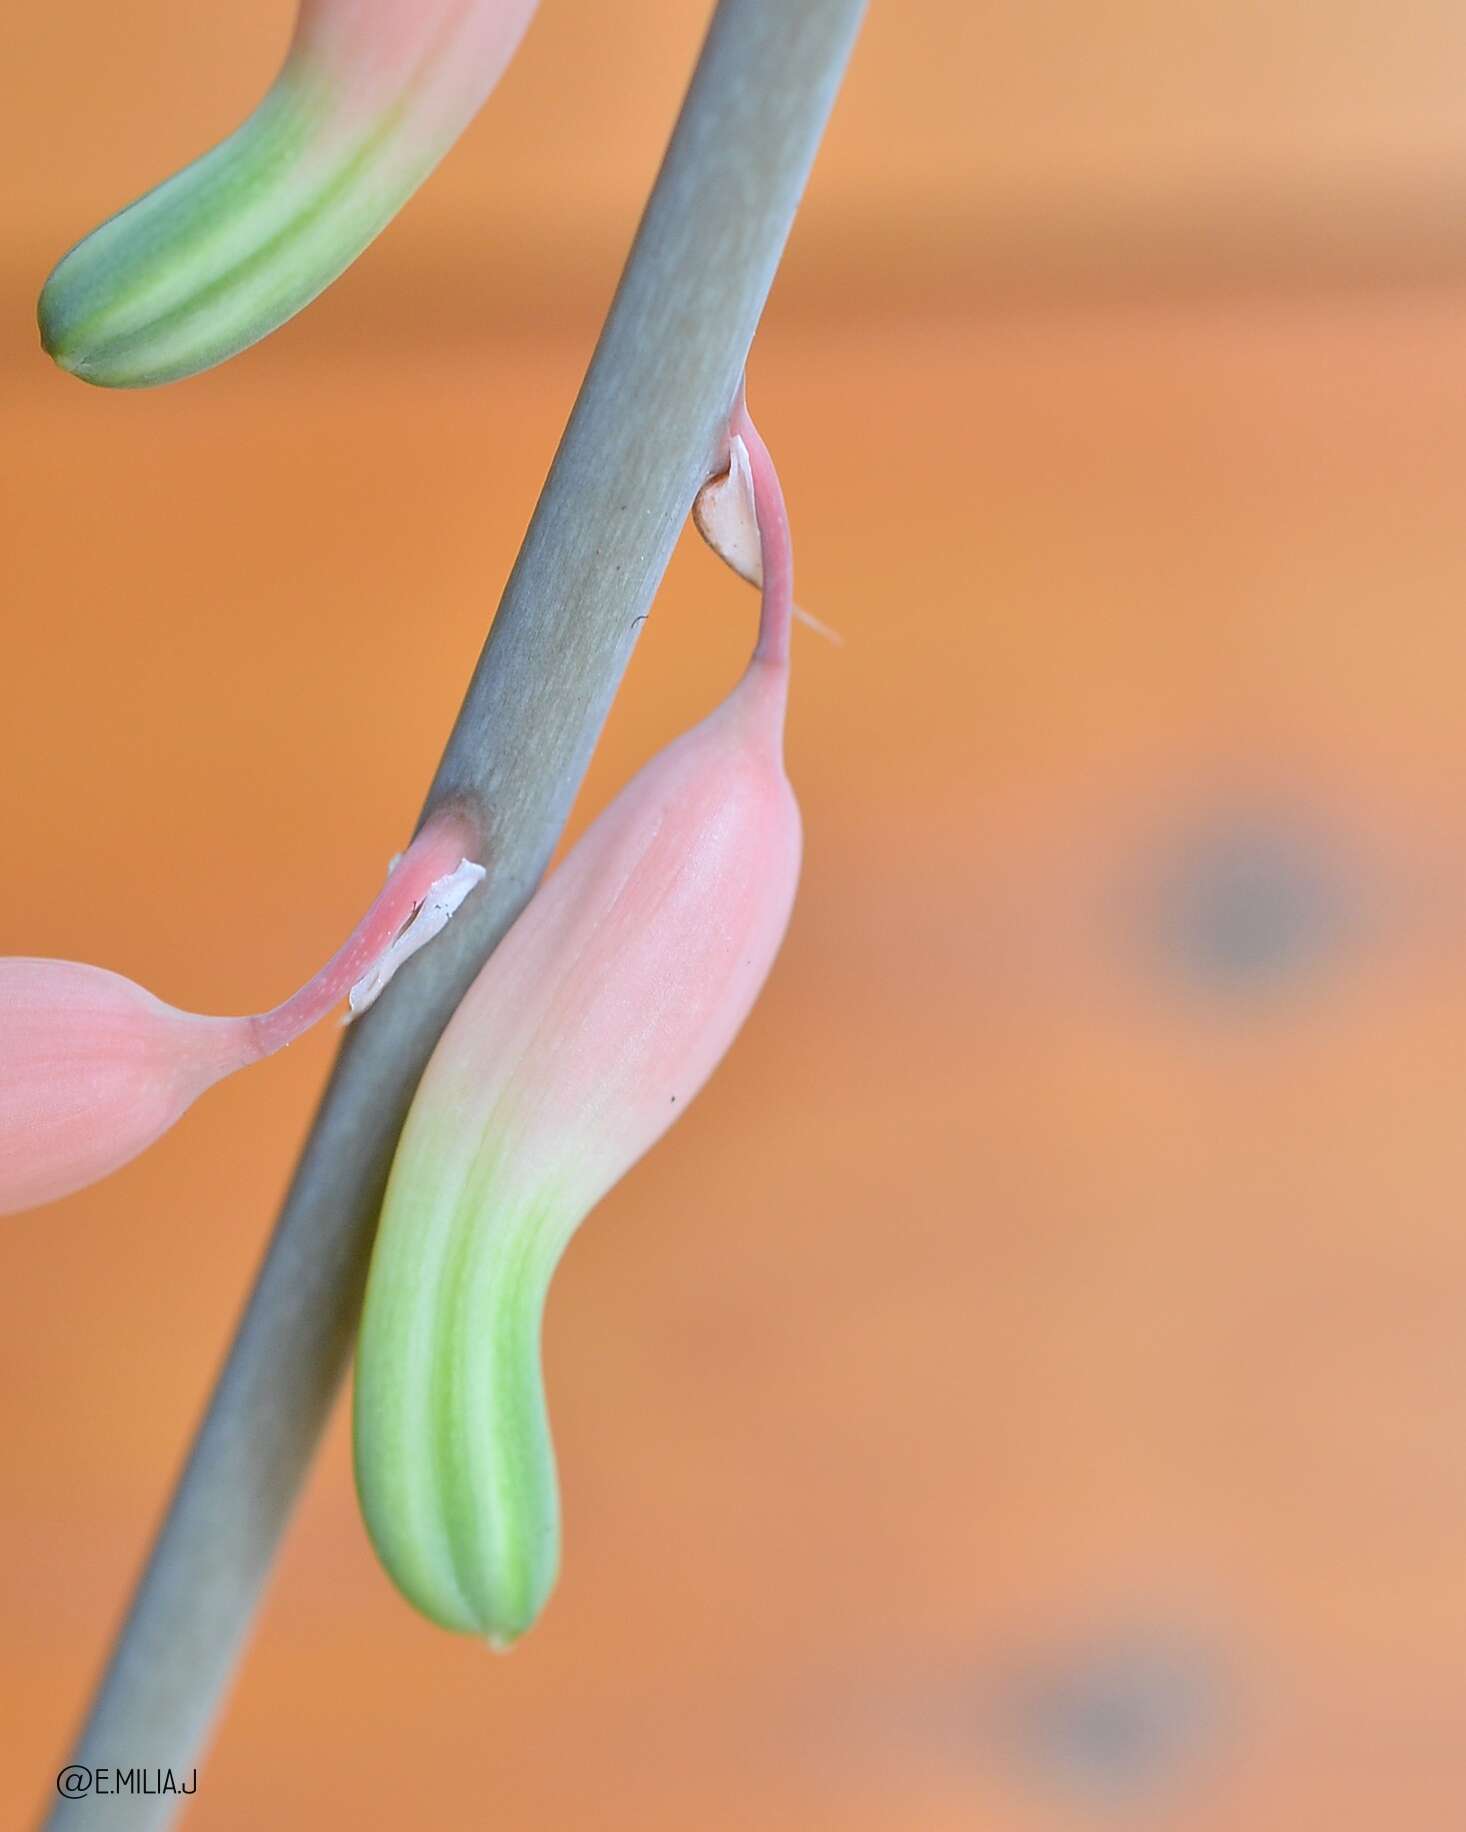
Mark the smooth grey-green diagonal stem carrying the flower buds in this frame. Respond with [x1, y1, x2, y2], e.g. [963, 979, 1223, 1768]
[49, 0, 863, 1832]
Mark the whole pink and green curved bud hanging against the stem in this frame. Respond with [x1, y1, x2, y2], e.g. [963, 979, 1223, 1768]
[356, 410, 801, 1645]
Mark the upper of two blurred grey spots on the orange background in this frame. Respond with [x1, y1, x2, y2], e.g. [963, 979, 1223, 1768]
[1147, 813, 1351, 997]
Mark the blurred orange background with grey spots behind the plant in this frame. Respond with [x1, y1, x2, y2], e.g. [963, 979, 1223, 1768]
[0, 0, 1466, 1832]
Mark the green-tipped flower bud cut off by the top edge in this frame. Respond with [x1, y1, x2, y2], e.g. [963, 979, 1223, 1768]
[38, 0, 535, 388]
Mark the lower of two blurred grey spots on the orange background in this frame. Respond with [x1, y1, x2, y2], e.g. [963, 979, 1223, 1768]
[999, 1634, 1228, 1803]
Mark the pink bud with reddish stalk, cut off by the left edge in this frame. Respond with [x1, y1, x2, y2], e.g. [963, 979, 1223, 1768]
[0, 813, 484, 1215]
